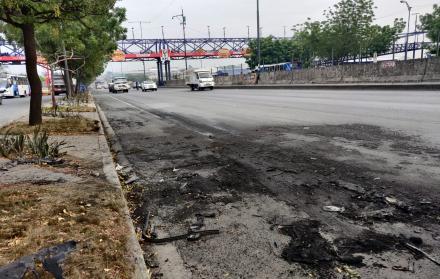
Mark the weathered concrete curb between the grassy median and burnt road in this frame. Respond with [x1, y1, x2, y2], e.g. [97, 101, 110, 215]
[95, 104, 151, 279]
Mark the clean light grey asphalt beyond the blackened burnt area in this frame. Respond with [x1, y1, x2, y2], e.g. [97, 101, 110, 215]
[99, 89, 440, 145]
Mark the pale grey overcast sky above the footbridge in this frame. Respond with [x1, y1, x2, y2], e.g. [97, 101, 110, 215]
[118, 0, 440, 38]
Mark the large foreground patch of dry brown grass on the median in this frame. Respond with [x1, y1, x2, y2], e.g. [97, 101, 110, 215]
[0, 181, 133, 278]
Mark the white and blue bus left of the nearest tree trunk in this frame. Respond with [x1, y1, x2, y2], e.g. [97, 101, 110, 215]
[0, 75, 31, 98]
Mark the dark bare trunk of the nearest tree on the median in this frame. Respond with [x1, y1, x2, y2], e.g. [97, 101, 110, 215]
[21, 24, 43, 126]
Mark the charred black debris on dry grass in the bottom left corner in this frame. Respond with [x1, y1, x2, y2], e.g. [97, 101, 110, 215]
[0, 240, 77, 279]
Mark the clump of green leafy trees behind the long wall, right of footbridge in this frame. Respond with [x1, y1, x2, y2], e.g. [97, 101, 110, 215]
[247, 0, 405, 67]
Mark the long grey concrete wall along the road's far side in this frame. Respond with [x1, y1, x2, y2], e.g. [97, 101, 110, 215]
[212, 58, 440, 85]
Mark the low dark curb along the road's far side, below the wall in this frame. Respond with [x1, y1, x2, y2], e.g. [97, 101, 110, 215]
[216, 83, 440, 91]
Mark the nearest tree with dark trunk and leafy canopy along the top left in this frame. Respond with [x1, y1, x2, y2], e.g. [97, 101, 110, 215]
[0, 0, 116, 125]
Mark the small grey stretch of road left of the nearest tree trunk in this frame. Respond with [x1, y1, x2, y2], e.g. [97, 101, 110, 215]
[0, 97, 30, 126]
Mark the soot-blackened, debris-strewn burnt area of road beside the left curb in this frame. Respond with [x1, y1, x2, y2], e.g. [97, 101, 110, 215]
[100, 94, 440, 279]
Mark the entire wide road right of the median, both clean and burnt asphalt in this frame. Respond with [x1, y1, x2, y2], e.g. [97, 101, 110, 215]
[95, 89, 440, 279]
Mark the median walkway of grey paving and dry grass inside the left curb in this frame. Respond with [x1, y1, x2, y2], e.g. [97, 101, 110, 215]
[0, 97, 149, 278]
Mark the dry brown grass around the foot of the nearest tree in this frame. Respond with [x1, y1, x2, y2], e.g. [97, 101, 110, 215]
[0, 116, 99, 135]
